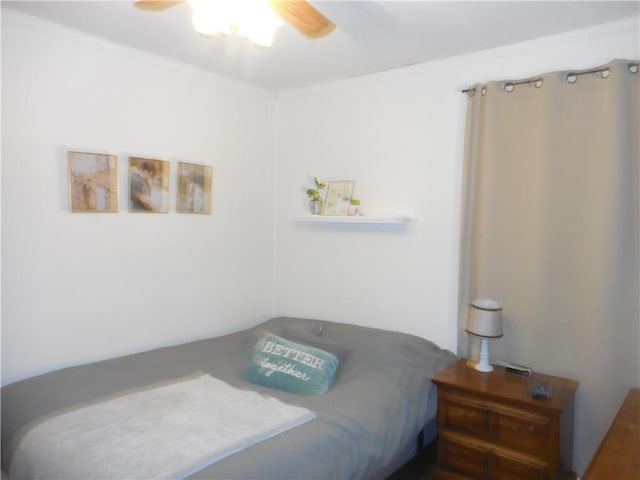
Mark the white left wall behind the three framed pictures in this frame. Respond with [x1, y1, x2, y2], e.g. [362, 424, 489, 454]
[2, 9, 274, 384]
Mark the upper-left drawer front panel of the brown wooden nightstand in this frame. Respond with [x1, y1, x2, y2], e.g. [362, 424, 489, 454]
[438, 395, 489, 439]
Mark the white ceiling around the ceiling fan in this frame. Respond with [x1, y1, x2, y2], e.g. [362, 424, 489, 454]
[2, 0, 640, 90]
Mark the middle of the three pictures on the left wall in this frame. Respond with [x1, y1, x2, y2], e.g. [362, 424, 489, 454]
[129, 157, 170, 213]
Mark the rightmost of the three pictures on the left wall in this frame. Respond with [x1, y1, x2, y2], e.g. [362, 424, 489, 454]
[176, 162, 213, 214]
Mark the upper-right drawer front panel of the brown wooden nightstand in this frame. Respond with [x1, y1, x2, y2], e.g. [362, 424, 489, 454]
[492, 411, 551, 456]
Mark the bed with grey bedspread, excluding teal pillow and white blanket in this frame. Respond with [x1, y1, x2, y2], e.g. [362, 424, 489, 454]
[1, 317, 455, 479]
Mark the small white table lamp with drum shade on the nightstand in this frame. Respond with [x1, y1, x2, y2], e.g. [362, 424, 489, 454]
[467, 299, 502, 372]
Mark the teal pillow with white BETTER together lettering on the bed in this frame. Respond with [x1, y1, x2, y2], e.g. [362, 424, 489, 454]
[244, 333, 339, 394]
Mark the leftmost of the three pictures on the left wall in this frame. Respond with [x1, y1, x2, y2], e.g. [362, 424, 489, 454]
[67, 151, 118, 213]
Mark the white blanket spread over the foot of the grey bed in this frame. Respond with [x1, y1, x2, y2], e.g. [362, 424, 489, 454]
[9, 375, 315, 479]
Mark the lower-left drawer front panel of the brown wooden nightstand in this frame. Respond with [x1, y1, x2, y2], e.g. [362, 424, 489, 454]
[438, 436, 489, 478]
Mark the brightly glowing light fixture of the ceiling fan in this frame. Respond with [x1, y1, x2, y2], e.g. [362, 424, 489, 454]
[189, 0, 284, 47]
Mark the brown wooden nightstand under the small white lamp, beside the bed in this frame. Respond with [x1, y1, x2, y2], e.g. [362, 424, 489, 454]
[433, 360, 578, 480]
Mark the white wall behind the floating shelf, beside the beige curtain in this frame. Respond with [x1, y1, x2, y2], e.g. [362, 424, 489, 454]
[276, 19, 640, 472]
